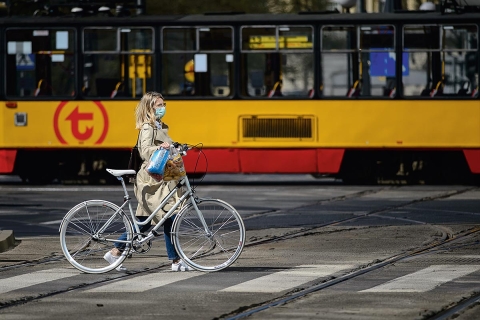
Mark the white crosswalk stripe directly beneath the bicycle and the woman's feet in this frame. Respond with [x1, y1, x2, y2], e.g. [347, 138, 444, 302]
[85, 271, 203, 292]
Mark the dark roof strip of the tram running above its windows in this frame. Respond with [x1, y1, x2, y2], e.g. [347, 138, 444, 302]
[0, 11, 480, 26]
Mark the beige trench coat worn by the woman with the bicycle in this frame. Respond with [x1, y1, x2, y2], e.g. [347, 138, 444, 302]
[133, 123, 183, 224]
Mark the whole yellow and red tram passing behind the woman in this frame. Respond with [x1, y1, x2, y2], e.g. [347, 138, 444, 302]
[0, 8, 480, 183]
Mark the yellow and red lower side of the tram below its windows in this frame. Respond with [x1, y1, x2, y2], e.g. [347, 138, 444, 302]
[0, 100, 480, 182]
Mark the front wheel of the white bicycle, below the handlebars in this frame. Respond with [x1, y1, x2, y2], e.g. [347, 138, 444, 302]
[172, 199, 245, 271]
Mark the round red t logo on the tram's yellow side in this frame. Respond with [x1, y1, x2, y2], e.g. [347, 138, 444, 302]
[53, 101, 108, 145]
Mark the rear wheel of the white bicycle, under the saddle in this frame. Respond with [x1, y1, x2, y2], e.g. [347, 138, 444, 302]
[60, 200, 133, 273]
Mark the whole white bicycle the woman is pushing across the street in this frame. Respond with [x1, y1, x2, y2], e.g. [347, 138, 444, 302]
[59, 145, 245, 273]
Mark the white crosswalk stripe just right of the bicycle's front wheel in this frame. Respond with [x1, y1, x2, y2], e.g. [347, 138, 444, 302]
[220, 264, 353, 293]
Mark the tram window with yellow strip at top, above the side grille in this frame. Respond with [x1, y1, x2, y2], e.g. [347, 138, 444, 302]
[241, 26, 314, 98]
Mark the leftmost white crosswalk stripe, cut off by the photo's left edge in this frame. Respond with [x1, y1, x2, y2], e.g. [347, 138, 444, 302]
[0, 269, 80, 294]
